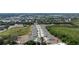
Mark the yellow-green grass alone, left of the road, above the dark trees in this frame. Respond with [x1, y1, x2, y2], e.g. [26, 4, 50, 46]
[0, 26, 31, 40]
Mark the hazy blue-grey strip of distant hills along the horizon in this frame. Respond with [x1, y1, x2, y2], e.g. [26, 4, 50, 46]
[0, 13, 79, 16]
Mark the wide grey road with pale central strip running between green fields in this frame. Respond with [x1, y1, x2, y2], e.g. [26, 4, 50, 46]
[29, 24, 65, 45]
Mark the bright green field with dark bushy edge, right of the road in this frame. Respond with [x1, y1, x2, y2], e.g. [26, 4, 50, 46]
[47, 25, 79, 45]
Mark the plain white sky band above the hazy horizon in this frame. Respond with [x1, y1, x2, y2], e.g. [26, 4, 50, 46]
[0, 0, 79, 13]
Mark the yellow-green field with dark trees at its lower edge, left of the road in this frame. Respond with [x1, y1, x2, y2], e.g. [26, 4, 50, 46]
[0, 26, 31, 44]
